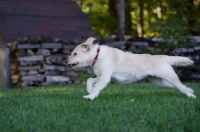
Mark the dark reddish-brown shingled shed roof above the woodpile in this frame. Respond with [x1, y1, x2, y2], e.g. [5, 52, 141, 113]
[0, 0, 93, 41]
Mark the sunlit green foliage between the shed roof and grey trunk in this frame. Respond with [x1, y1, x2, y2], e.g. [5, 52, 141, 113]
[82, 0, 118, 36]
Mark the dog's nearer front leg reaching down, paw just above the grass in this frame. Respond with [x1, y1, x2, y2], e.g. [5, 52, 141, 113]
[83, 75, 111, 100]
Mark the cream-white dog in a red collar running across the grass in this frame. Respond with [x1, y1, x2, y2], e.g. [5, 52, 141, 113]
[64, 37, 196, 100]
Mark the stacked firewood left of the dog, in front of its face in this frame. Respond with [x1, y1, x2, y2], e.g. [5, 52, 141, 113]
[10, 36, 87, 87]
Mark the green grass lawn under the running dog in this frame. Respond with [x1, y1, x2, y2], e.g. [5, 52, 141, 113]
[0, 83, 200, 132]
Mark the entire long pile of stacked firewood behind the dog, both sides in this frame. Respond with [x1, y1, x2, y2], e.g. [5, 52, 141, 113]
[10, 36, 200, 87]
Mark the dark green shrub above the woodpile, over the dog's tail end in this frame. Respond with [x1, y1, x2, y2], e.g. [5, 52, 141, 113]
[152, 19, 193, 49]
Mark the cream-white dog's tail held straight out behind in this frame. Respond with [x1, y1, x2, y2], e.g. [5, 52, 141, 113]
[161, 55, 194, 66]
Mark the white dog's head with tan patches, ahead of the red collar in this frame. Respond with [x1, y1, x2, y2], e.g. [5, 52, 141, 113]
[63, 37, 98, 69]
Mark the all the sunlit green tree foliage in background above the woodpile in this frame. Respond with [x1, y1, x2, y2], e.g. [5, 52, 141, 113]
[74, 0, 200, 36]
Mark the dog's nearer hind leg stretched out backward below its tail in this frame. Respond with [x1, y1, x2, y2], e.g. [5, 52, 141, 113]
[156, 67, 196, 98]
